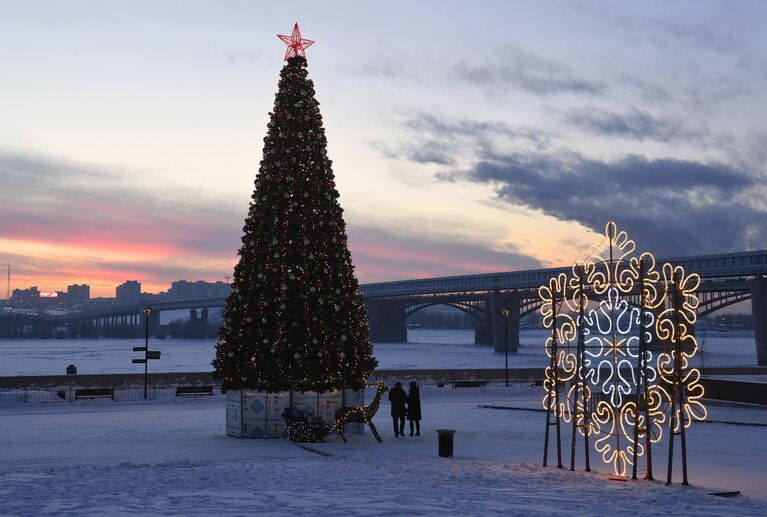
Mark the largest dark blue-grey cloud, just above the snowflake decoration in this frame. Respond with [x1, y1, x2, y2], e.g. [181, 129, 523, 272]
[439, 152, 767, 255]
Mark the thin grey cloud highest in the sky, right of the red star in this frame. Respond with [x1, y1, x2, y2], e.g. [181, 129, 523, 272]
[453, 47, 607, 97]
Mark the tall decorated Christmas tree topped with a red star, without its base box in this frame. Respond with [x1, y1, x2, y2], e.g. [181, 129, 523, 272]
[213, 24, 377, 392]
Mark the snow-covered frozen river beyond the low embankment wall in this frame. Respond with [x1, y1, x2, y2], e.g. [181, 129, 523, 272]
[0, 329, 756, 376]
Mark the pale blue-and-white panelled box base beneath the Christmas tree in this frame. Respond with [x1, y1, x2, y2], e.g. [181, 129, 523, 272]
[226, 384, 365, 439]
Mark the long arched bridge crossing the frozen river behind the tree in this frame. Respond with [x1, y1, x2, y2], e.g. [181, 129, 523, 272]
[60, 250, 767, 365]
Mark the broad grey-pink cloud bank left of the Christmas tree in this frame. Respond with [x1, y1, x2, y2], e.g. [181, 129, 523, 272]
[0, 151, 247, 255]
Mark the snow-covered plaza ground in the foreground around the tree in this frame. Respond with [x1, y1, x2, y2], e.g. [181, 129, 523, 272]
[0, 386, 767, 517]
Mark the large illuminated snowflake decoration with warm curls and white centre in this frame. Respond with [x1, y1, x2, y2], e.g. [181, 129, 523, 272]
[538, 222, 706, 476]
